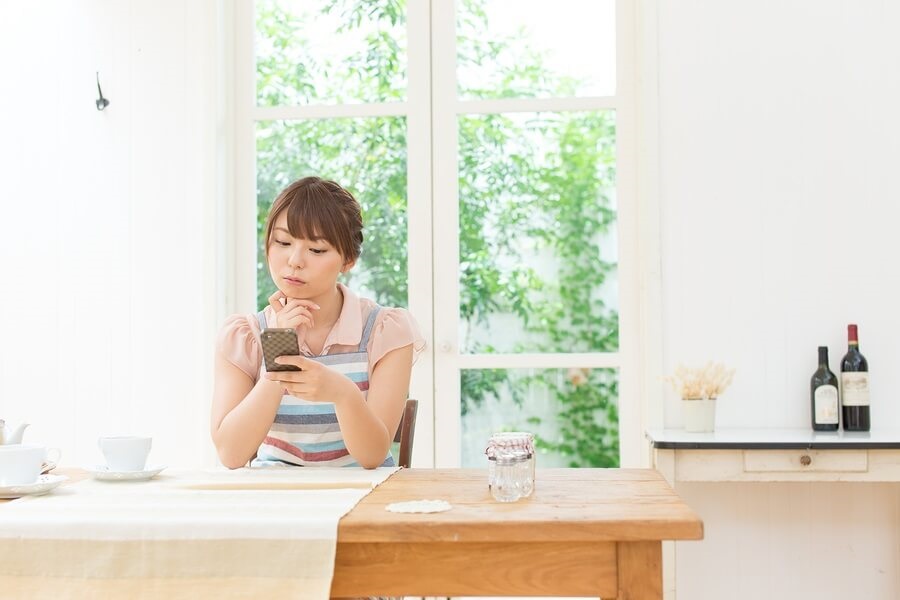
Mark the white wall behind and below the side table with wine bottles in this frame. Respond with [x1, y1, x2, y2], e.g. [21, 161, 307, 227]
[658, 0, 900, 600]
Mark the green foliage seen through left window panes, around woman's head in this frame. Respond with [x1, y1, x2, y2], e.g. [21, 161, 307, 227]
[256, 0, 408, 308]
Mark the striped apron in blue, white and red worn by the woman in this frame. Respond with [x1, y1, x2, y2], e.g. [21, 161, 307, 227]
[251, 306, 394, 467]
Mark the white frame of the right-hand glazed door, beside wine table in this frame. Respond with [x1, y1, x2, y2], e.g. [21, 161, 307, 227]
[431, 0, 645, 467]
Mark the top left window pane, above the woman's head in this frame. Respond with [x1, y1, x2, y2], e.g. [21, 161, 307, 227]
[255, 0, 406, 106]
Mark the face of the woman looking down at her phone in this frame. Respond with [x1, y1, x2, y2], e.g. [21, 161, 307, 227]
[269, 211, 353, 298]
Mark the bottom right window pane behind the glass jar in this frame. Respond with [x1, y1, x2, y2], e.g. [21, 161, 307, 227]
[461, 369, 619, 468]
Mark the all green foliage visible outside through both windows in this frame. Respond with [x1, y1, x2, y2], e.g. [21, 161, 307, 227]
[257, 0, 619, 466]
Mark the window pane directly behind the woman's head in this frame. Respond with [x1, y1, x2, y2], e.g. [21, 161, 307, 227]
[256, 117, 408, 308]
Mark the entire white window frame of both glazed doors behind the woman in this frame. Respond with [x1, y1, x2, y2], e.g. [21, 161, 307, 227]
[229, 0, 662, 467]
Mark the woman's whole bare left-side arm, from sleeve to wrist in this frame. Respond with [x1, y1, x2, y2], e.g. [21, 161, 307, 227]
[210, 351, 282, 469]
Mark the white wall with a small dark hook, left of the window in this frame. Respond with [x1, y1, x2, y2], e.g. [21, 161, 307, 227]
[0, 0, 221, 465]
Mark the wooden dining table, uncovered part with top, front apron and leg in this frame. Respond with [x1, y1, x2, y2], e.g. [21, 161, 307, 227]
[0, 469, 703, 600]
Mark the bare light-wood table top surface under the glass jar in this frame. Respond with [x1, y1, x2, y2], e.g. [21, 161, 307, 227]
[0, 469, 703, 543]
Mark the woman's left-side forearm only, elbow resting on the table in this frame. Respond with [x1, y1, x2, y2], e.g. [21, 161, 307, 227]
[213, 378, 283, 469]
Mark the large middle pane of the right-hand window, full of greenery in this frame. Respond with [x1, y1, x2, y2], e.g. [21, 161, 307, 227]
[459, 111, 619, 353]
